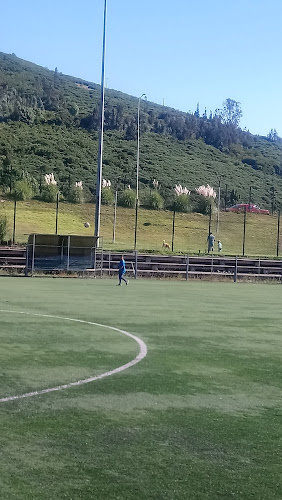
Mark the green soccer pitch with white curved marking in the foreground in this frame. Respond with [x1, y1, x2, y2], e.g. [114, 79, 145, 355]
[0, 278, 282, 500]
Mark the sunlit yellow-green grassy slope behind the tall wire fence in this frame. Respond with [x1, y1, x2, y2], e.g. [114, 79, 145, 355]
[0, 197, 277, 256]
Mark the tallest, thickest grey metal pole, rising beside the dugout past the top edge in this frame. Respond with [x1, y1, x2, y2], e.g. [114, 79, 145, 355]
[94, 0, 107, 238]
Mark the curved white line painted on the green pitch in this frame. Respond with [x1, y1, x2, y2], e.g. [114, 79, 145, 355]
[0, 309, 147, 403]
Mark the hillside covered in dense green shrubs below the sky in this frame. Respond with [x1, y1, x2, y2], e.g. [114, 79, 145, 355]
[0, 53, 282, 208]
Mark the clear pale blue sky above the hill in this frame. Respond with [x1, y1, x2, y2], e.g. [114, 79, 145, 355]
[0, 0, 282, 137]
